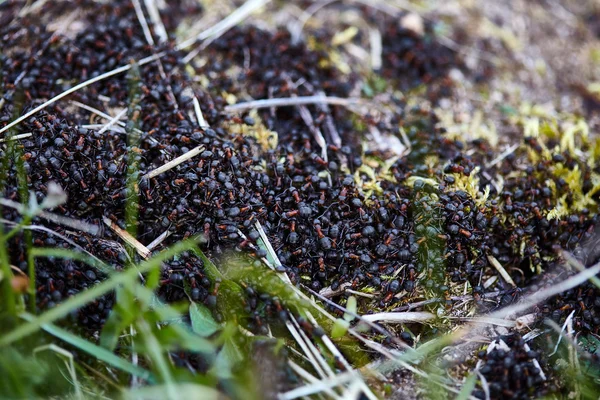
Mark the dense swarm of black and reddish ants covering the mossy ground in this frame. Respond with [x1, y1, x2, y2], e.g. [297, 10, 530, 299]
[0, 0, 600, 397]
